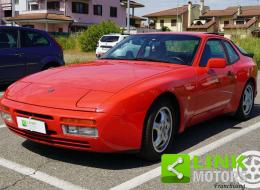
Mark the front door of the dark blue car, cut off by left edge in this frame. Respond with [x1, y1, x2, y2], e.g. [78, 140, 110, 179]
[0, 28, 26, 83]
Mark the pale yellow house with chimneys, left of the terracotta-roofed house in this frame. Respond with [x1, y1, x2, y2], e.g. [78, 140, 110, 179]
[144, 0, 208, 32]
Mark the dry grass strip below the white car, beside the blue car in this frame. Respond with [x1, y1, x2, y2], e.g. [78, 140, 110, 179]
[64, 50, 96, 65]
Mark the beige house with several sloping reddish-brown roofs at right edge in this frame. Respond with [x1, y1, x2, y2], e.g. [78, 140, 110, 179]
[188, 6, 260, 38]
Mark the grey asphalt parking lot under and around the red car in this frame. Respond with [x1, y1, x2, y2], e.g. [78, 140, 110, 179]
[0, 75, 260, 190]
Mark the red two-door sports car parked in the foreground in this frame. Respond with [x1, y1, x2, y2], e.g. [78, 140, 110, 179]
[0, 33, 257, 160]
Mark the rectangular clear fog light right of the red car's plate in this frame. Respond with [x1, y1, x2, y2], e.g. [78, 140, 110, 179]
[62, 125, 98, 137]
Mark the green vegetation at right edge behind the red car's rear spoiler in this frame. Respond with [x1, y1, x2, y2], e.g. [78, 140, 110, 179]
[232, 37, 260, 69]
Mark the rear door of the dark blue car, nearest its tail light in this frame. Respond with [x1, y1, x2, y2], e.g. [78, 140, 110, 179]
[20, 29, 50, 74]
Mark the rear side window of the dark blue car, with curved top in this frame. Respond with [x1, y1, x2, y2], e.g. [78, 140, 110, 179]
[21, 31, 50, 48]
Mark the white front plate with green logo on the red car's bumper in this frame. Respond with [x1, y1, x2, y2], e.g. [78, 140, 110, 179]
[16, 117, 46, 134]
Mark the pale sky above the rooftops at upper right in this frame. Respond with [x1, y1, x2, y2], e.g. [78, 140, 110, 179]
[135, 0, 260, 16]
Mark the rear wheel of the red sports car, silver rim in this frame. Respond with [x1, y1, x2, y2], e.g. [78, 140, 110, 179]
[235, 82, 255, 121]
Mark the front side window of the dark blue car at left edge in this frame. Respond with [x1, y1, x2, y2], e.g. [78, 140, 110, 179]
[0, 30, 18, 49]
